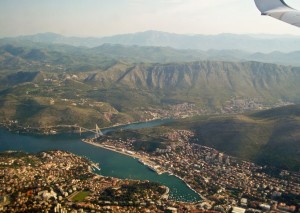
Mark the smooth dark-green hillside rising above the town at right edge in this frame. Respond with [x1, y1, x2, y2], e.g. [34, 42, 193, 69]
[172, 105, 300, 171]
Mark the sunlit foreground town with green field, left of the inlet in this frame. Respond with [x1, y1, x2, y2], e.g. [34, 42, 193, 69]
[0, 151, 216, 213]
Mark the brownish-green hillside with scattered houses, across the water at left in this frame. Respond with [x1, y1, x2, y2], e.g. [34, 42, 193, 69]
[0, 80, 132, 127]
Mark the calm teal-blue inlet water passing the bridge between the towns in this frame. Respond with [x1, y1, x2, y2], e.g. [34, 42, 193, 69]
[0, 121, 201, 201]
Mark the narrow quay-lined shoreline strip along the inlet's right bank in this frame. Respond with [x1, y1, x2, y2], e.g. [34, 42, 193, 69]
[81, 139, 207, 203]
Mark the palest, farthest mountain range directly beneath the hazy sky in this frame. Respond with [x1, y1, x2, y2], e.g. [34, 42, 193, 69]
[0, 31, 300, 53]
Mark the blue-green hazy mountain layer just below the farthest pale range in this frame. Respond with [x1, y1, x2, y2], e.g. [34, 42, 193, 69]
[0, 40, 300, 72]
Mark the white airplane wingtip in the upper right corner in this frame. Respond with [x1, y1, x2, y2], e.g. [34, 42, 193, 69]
[255, 0, 300, 27]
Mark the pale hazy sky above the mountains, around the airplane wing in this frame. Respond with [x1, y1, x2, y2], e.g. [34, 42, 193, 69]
[0, 0, 300, 37]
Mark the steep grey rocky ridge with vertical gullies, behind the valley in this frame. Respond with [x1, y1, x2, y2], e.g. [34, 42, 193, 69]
[85, 61, 300, 106]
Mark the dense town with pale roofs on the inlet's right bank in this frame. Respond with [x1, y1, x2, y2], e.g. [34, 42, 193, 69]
[84, 130, 300, 212]
